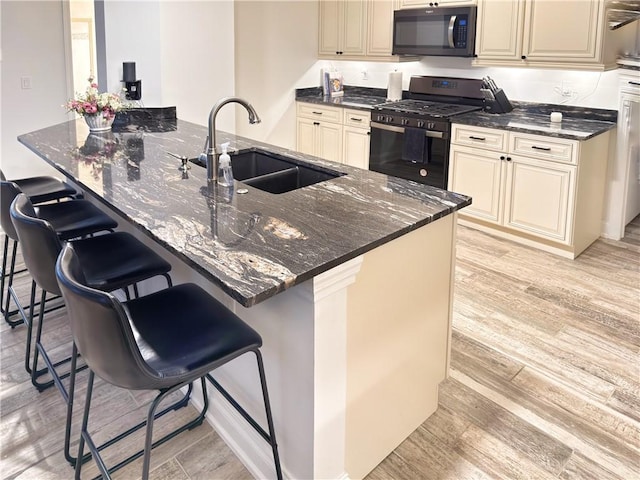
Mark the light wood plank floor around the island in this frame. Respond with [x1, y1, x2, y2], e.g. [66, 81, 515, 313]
[0, 219, 640, 480]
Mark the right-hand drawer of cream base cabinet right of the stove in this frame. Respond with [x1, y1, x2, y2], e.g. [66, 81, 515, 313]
[509, 132, 578, 165]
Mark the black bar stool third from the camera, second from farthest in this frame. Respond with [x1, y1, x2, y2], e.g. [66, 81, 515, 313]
[0, 181, 118, 327]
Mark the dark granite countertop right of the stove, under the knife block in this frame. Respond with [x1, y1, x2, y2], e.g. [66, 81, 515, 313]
[451, 102, 617, 140]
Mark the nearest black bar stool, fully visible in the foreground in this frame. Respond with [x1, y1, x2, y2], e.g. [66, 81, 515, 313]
[56, 243, 282, 480]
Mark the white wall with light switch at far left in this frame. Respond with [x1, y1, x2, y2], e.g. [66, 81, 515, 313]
[0, 0, 67, 178]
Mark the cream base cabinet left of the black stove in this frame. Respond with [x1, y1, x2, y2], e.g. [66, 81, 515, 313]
[296, 102, 371, 169]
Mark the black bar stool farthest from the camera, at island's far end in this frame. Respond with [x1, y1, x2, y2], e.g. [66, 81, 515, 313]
[0, 173, 82, 327]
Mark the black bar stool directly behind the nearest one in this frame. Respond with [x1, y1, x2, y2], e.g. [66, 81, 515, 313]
[10, 194, 175, 464]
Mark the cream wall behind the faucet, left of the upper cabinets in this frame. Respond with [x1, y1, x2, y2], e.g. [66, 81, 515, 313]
[235, 1, 319, 148]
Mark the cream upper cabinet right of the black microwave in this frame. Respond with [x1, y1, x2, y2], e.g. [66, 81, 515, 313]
[474, 0, 635, 70]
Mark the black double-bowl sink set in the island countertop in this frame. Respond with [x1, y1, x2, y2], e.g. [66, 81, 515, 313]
[192, 148, 345, 194]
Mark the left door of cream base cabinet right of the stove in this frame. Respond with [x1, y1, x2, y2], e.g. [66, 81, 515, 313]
[448, 145, 506, 223]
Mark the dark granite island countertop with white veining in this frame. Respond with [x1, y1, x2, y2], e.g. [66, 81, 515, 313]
[18, 119, 471, 307]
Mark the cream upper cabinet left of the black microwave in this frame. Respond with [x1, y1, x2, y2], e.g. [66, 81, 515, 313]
[318, 0, 416, 62]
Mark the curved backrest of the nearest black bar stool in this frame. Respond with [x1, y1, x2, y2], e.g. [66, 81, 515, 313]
[56, 243, 161, 390]
